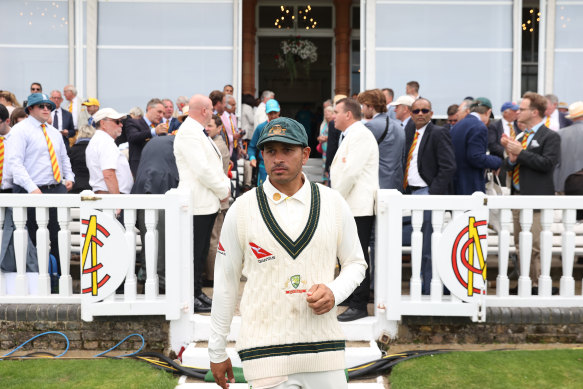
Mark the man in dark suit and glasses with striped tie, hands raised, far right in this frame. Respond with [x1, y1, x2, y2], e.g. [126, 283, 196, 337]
[501, 92, 561, 293]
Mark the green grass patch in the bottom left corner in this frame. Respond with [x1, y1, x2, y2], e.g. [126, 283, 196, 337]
[0, 359, 178, 389]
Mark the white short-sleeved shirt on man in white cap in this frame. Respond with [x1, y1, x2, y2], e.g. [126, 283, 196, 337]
[85, 130, 134, 194]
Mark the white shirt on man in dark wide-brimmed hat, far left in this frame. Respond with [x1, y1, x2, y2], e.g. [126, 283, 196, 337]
[4, 116, 75, 193]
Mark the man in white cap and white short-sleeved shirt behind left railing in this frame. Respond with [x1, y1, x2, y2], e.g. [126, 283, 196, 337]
[85, 108, 134, 194]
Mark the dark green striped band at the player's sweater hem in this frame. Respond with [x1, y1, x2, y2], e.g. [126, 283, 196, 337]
[238, 340, 346, 361]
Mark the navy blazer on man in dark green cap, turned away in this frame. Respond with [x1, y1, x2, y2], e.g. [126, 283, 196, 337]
[450, 114, 502, 195]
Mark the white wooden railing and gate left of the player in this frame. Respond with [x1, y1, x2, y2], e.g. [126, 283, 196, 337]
[0, 190, 194, 320]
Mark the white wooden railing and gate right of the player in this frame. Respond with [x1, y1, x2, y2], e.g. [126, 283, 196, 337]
[375, 190, 583, 320]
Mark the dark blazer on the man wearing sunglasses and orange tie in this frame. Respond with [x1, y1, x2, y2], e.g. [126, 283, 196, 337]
[403, 120, 456, 195]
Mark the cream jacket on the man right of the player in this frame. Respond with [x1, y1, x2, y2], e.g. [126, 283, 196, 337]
[330, 122, 379, 216]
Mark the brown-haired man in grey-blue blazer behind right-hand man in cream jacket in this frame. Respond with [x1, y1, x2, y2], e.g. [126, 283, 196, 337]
[358, 89, 405, 191]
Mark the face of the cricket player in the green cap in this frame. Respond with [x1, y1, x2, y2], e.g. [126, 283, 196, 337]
[261, 142, 310, 185]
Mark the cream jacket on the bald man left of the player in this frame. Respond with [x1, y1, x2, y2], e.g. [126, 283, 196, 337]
[174, 117, 231, 215]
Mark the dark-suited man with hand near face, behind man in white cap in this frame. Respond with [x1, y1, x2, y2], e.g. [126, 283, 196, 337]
[125, 99, 168, 177]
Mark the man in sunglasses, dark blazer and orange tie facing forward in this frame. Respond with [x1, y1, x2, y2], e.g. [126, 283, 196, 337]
[403, 98, 456, 294]
